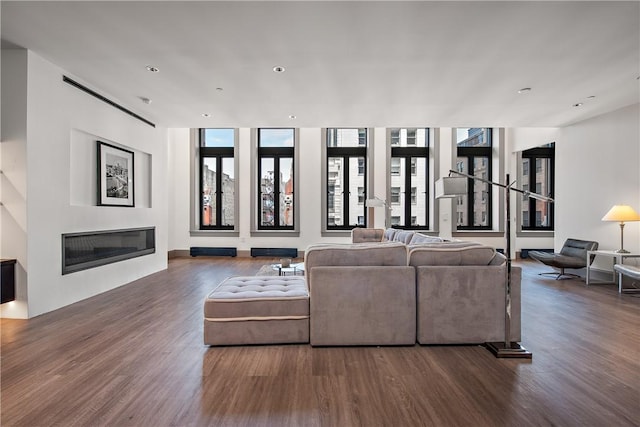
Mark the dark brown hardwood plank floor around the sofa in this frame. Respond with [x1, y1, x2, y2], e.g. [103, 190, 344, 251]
[0, 258, 640, 427]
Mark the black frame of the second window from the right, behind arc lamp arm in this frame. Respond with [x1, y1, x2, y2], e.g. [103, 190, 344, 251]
[456, 128, 493, 231]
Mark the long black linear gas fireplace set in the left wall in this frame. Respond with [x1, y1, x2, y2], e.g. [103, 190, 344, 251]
[62, 227, 156, 274]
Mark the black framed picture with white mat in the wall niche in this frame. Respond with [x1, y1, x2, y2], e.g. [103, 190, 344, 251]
[98, 141, 135, 207]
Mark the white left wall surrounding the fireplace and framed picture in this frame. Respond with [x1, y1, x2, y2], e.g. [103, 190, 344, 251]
[2, 52, 168, 317]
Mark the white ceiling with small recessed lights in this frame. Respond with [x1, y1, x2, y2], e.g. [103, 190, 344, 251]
[0, 1, 640, 127]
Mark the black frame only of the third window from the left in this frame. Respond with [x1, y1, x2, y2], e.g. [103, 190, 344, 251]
[324, 128, 369, 231]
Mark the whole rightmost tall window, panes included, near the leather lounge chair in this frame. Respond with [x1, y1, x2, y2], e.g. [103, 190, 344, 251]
[520, 143, 555, 230]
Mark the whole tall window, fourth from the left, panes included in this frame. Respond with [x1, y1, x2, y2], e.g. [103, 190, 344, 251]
[389, 128, 429, 228]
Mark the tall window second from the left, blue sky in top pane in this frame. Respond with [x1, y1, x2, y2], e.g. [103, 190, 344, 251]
[258, 129, 295, 230]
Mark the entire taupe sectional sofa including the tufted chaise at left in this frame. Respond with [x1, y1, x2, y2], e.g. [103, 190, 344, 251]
[204, 229, 521, 346]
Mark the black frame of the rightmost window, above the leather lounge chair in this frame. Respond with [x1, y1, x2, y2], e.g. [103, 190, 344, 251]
[519, 143, 556, 231]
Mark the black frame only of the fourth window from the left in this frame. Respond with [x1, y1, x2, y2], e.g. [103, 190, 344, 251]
[389, 128, 431, 230]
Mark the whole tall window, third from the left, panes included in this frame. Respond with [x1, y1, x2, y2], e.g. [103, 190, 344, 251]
[326, 128, 367, 230]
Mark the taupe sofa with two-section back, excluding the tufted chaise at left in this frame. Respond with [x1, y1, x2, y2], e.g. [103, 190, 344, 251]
[305, 229, 521, 346]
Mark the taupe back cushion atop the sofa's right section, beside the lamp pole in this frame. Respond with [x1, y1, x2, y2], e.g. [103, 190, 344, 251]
[408, 243, 496, 266]
